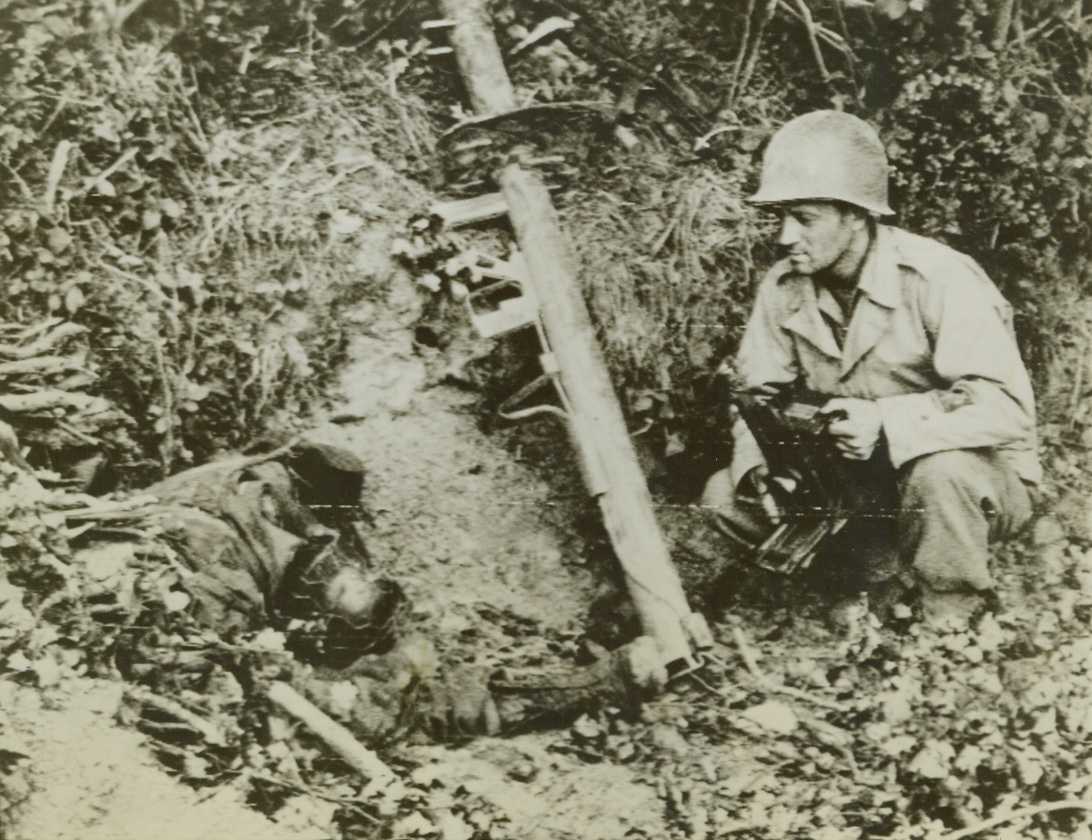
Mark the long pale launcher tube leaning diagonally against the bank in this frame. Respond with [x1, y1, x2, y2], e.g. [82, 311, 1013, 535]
[439, 0, 709, 671]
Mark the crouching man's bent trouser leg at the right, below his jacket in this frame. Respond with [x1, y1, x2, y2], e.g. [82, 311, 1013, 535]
[899, 450, 1031, 617]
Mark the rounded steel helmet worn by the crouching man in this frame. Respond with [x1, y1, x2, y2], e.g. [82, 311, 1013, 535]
[748, 110, 894, 215]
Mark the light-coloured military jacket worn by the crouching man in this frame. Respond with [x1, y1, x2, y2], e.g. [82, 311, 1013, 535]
[732, 225, 1042, 483]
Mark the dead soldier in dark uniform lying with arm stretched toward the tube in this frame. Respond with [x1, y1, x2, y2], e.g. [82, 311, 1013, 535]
[76, 442, 666, 741]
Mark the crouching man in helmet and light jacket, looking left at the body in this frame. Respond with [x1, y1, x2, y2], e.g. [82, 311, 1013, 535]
[704, 111, 1041, 618]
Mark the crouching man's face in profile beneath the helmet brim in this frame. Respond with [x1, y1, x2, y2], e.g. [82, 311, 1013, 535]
[778, 201, 859, 276]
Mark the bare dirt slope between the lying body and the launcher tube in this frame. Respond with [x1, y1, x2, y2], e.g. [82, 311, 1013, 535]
[311, 255, 591, 643]
